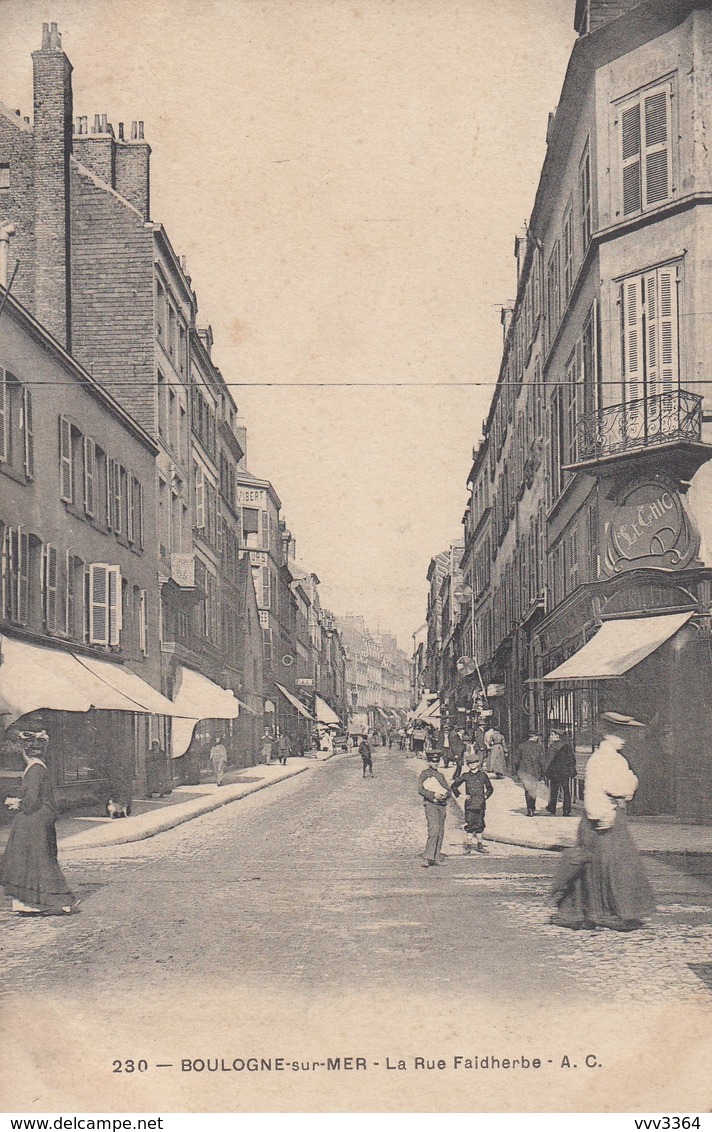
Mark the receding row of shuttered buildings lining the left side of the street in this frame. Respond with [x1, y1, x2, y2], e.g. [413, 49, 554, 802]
[0, 24, 348, 812]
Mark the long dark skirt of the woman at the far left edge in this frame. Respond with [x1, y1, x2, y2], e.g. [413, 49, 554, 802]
[0, 806, 76, 911]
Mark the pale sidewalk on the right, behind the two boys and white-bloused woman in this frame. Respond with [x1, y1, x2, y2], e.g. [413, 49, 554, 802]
[412, 758, 712, 854]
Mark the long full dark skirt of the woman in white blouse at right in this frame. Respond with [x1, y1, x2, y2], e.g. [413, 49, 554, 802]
[554, 811, 654, 931]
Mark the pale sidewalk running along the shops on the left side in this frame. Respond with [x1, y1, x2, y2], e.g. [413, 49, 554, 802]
[0, 756, 310, 855]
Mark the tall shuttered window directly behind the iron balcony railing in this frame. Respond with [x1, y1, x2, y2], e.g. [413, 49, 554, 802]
[618, 264, 680, 414]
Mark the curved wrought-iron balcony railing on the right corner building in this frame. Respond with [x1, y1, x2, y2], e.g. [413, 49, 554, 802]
[575, 389, 702, 464]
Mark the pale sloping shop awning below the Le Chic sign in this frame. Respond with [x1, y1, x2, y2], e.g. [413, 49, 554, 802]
[543, 612, 693, 684]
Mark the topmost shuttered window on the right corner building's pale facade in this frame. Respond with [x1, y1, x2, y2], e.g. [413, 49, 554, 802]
[616, 82, 675, 216]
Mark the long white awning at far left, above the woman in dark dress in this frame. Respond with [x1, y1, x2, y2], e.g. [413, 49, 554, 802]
[0, 636, 175, 727]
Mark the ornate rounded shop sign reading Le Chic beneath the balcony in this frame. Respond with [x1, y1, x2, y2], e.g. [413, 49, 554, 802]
[604, 480, 700, 576]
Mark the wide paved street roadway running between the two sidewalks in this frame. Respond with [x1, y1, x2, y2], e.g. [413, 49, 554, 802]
[2, 749, 712, 1108]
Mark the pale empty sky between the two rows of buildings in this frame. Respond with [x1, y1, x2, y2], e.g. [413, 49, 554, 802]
[0, 0, 574, 651]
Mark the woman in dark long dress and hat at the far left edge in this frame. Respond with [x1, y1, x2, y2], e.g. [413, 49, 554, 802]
[0, 731, 77, 916]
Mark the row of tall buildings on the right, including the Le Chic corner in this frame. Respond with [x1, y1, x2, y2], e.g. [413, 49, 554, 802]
[415, 0, 712, 823]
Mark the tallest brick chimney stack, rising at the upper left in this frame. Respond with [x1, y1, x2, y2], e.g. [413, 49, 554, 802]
[32, 24, 72, 349]
